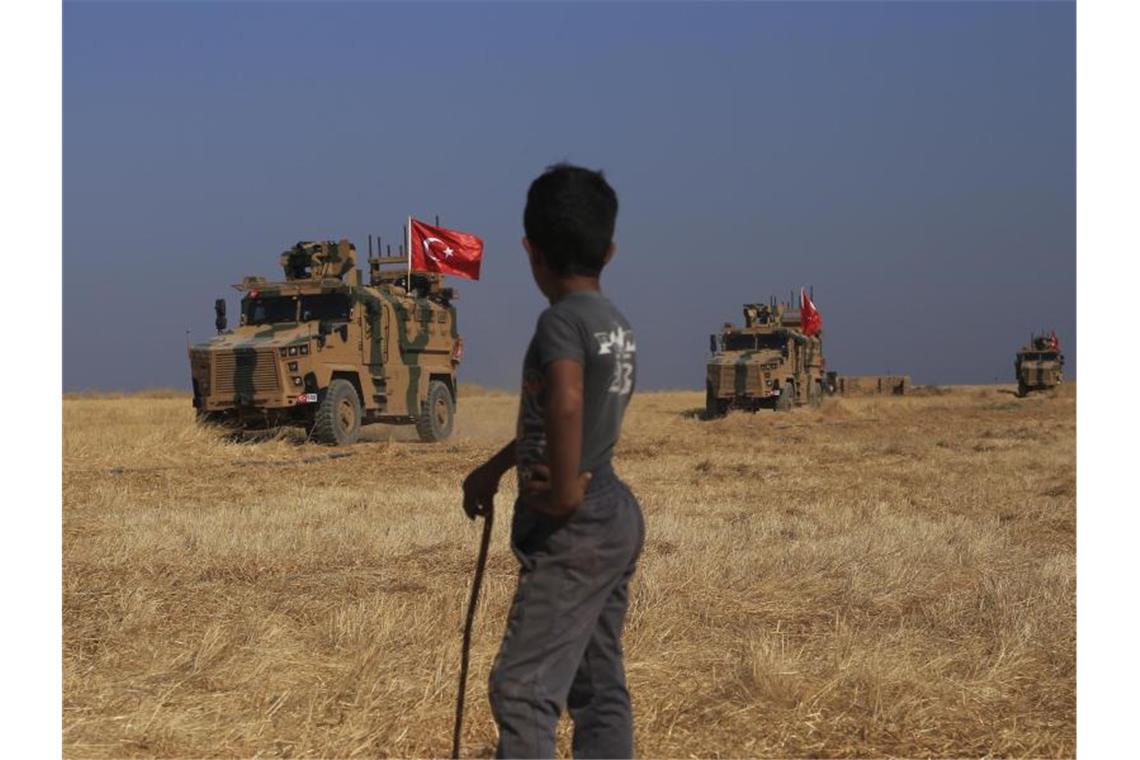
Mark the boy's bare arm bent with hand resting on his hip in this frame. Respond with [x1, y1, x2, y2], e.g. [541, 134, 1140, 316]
[531, 359, 591, 517]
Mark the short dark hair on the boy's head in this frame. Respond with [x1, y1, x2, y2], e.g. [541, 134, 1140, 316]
[522, 163, 618, 276]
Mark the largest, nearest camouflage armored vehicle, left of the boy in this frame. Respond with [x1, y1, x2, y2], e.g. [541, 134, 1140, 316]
[189, 240, 463, 444]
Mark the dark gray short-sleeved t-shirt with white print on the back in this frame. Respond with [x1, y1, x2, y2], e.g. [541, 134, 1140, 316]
[515, 291, 637, 480]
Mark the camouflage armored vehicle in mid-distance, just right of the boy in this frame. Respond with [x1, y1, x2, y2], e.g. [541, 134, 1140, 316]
[705, 301, 825, 417]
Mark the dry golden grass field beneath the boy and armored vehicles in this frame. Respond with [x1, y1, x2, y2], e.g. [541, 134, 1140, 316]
[63, 386, 1076, 758]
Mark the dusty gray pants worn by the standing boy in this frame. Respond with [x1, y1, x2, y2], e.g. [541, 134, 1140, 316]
[490, 467, 645, 758]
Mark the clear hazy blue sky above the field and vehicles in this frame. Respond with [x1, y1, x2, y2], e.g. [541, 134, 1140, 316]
[64, 2, 1076, 390]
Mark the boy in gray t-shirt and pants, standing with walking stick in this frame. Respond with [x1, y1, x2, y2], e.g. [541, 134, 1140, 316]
[463, 164, 645, 758]
